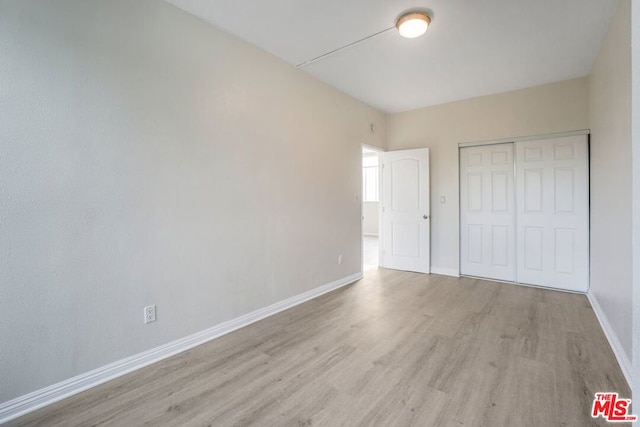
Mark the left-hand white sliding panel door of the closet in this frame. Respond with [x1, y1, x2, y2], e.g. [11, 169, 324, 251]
[460, 143, 516, 281]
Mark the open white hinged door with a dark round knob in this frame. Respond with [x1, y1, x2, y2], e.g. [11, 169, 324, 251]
[381, 148, 430, 273]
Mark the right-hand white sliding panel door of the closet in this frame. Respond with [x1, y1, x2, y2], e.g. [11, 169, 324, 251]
[516, 135, 589, 292]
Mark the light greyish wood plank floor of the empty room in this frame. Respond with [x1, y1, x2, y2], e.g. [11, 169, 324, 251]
[9, 269, 631, 427]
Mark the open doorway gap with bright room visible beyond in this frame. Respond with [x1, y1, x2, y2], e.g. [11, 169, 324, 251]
[362, 146, 380, 271]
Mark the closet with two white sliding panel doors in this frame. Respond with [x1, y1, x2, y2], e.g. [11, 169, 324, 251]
[460, 134, 589, 292]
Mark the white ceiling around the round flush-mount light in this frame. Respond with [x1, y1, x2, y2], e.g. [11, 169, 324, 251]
[167, 0, 616, 113]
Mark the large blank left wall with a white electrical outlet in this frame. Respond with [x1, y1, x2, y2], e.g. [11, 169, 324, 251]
[0, 0, 385, 402]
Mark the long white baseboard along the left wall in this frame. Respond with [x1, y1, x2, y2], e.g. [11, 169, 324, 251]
[0, 272, 362, 424]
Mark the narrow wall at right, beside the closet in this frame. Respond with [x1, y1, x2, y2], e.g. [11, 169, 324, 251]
[589, 0, 633, 363]
